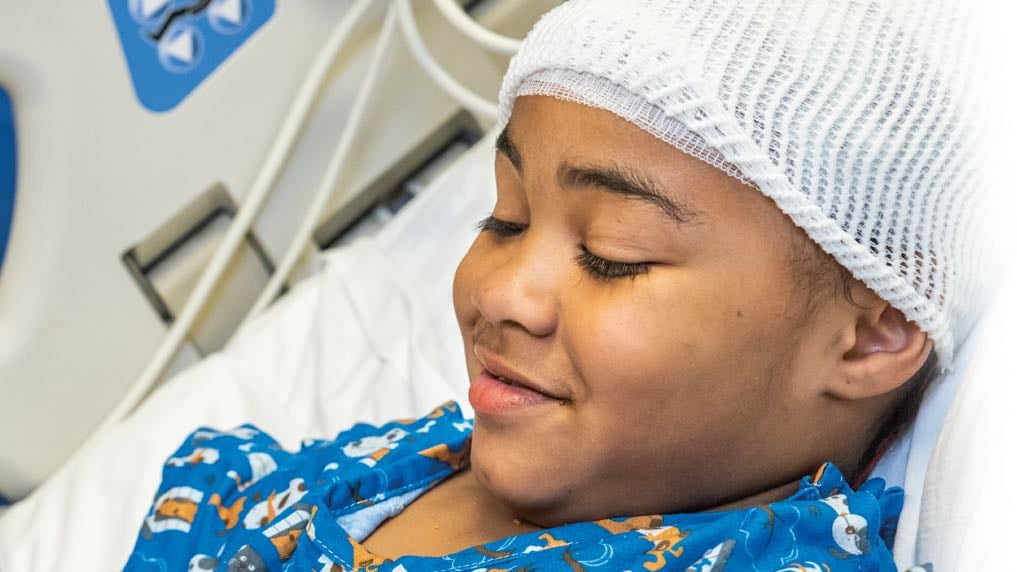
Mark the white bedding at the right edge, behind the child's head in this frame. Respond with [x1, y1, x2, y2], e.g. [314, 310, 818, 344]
[914, 265, 1017, 572]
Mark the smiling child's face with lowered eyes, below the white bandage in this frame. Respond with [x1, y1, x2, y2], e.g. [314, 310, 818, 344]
[455, 97, 850, 525]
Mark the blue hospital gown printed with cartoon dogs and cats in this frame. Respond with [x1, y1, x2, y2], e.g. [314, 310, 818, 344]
[126, 402, 903, 572]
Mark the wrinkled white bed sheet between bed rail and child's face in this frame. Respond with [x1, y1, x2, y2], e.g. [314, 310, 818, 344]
[0, 136, 494, 572]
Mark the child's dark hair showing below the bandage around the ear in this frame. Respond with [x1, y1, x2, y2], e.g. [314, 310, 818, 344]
[791, 232, 939, 483]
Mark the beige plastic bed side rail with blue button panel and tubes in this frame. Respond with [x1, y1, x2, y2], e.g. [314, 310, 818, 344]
[0, 0, 558, 499]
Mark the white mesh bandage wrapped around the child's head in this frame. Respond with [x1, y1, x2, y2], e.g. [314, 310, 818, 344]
[499, 0, 985, 366]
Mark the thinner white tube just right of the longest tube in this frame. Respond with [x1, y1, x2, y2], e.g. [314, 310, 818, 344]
[238, 6, 398, 323]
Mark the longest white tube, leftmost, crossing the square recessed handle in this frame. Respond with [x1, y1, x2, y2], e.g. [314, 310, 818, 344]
[93, 0, 372, 427]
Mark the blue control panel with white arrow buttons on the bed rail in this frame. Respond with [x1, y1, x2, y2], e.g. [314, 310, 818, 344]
[109, 0, 276, 112]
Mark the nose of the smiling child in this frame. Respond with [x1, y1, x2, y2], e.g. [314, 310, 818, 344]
[471, 233, 566, 337]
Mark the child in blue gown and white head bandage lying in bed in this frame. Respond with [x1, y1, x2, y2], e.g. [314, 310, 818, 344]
[127, 0, 981, 571]
